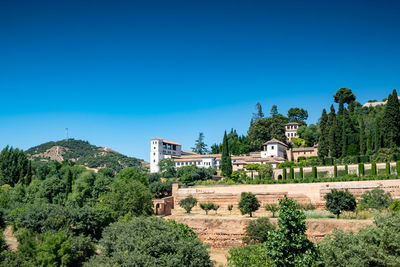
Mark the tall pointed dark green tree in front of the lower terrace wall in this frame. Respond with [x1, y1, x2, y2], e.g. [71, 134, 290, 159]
[266, 196, 319, 266]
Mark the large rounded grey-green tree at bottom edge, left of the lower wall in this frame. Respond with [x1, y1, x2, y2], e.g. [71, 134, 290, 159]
[85, 217, 211, 267]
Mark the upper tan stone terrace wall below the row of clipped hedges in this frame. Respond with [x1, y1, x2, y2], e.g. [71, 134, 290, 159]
[172, 180, 400, 213]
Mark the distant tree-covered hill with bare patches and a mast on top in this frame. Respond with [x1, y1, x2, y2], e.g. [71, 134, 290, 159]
[25, 139, 148, 171]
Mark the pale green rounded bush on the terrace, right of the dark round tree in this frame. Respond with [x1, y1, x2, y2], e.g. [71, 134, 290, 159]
[360, 188, 393, 210]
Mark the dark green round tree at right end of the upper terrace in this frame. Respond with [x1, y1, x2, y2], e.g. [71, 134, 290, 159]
[324, 189, 356, 218]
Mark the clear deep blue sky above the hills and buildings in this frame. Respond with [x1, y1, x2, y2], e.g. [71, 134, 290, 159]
[0, 0, 400, 160]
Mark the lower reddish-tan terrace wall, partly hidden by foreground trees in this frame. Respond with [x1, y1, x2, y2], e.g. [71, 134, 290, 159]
[165, 215, 372, 249]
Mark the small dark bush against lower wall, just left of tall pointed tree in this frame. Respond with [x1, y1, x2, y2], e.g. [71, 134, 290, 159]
[243, 217, 275, 244]
